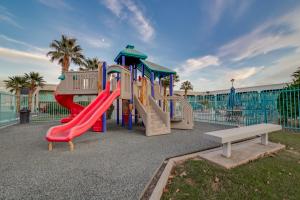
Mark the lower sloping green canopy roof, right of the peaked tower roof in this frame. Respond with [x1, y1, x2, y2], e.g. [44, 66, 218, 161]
[137, 60, 176, 78]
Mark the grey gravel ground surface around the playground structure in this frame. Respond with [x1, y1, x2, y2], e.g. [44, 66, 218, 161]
[0, 123, 231, 200]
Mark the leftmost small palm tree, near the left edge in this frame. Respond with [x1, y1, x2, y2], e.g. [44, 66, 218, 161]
[4, 76, 28, 112]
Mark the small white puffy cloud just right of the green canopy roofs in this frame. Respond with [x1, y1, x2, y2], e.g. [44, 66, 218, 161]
[176, 55, 220, 78]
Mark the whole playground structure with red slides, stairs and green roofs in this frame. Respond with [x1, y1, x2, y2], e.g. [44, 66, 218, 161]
[46, 45, 193, 150]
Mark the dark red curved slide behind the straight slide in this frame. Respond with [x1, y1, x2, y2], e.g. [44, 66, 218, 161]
[54, 93, 84, 123]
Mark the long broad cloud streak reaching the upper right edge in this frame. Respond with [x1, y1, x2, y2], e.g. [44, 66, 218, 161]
[218, 9, 300, 61]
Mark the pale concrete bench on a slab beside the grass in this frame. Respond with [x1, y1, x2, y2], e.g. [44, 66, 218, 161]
[204, 124, 282, 158]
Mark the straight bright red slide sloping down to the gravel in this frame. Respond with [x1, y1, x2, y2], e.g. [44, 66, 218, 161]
[46, 81, 121, 142]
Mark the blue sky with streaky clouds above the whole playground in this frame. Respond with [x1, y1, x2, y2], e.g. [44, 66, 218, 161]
[0, 0, 300, 91]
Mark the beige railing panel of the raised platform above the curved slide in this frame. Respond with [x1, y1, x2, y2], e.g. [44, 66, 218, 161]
[57, 71, 98, 94]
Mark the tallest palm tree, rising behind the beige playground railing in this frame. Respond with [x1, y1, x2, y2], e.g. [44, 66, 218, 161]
[47, 35, 85, 79]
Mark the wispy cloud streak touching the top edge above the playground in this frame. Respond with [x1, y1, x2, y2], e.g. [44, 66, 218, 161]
[102, 0, 155, 42]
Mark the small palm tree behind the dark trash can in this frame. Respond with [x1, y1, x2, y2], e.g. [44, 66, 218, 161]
[24, 72, 45, 110]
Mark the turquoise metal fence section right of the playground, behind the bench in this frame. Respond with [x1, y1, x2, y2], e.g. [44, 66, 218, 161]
[188, 87, 300, 131]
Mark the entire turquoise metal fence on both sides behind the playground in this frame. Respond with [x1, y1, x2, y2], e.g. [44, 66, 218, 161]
[0, 87, 300, 131]
